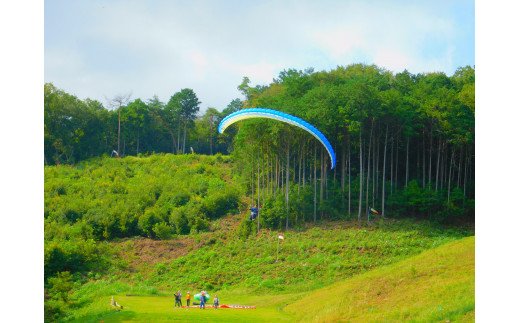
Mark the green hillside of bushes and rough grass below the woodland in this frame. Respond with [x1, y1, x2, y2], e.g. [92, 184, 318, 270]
[44, 155, 473, 322]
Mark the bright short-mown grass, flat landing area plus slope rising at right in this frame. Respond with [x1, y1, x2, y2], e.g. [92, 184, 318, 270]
[67, 237, 475, 322]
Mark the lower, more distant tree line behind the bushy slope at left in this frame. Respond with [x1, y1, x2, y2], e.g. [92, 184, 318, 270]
[44, 83, 242, 165]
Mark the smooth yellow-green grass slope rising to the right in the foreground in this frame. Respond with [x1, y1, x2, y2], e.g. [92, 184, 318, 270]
[285, 237, 475, 322]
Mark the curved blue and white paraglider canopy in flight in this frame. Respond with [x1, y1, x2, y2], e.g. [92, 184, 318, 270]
[218, 108, 336, 169]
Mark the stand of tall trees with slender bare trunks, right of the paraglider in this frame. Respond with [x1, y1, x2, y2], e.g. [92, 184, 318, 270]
[234, 64, 475, 228]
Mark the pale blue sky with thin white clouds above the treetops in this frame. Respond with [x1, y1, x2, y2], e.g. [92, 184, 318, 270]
[44, 0, 475, 110]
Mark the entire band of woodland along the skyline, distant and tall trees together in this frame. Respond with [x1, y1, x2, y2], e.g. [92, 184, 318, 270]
[45, 64, 475, 228]
